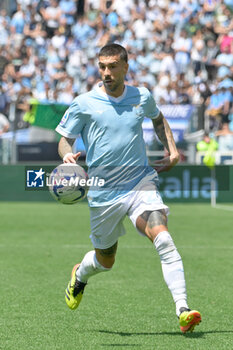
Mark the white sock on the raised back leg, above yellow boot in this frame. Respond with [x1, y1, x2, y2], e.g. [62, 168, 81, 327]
[76, 250, 111, 283]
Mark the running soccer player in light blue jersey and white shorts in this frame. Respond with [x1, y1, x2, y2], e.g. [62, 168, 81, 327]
[56, 43, 201, 333]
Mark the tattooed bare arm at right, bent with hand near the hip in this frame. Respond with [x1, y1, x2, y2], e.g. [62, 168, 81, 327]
[152, 112, 179, 172]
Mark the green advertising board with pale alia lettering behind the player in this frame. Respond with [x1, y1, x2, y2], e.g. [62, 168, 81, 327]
[0, 163, 233, 203]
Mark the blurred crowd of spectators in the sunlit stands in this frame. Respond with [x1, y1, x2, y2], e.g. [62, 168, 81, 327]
[0, 0, 233, 145]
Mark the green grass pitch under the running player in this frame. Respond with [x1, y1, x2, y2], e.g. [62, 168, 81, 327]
[0, 202, 233, 350]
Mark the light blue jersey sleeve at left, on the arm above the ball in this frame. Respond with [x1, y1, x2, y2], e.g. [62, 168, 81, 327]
[55, 99, 87, 139]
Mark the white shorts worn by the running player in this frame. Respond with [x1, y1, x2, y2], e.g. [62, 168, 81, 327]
[90, 178, 169, 249]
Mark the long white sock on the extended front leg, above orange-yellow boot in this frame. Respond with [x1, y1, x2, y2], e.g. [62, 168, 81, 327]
[154, 231, 188, 316]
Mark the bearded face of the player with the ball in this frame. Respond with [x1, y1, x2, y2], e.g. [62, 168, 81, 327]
[99, 55, 128, 97]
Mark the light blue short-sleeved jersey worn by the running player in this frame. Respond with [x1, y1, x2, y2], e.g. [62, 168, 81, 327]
[56, 83, 160, 207]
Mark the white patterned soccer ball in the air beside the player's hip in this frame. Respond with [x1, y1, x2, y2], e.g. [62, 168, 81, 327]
[49, 163, 87, 204]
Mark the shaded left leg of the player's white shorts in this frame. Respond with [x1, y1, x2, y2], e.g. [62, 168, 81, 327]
[90, 202, 127, 250]
